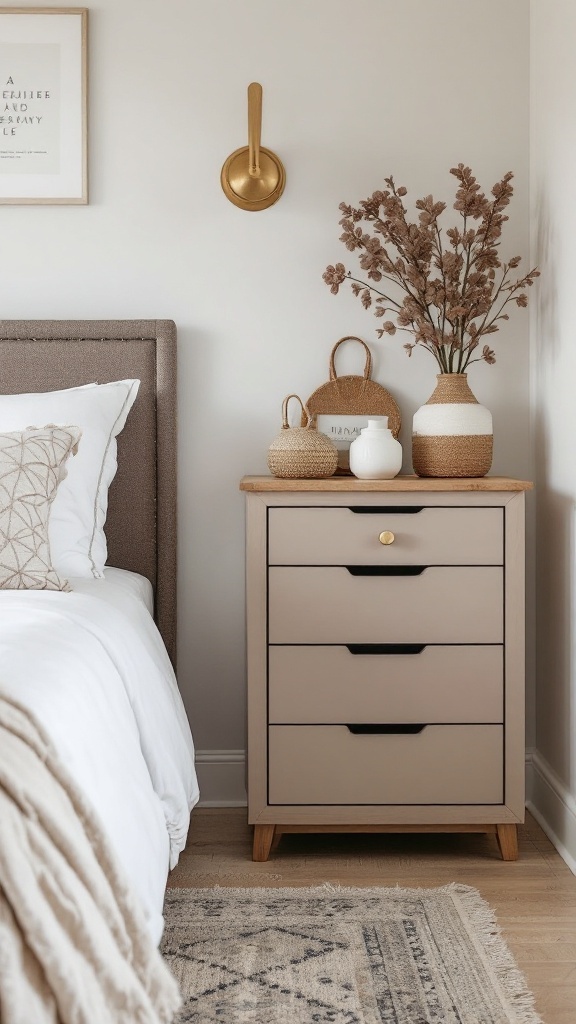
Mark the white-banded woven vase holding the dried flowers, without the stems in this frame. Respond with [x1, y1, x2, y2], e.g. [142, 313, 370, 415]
[412, 374, 493, 476]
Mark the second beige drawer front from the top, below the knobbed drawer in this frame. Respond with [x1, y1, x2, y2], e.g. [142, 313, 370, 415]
[269, 565, 503, 644]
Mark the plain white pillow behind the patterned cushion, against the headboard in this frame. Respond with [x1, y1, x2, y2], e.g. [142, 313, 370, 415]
[0, 380, 140, 579]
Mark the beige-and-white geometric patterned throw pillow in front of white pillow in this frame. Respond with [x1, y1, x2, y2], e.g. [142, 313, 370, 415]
[0, 424, 81, 590]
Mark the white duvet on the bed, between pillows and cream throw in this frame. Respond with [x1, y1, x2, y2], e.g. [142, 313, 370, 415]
[0, 568, 198, 941]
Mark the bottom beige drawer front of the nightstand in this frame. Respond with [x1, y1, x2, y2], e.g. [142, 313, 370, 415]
[269, 725, 503, 805]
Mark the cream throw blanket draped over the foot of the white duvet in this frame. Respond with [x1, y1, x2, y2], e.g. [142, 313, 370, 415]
[0, 688, 180, 1024]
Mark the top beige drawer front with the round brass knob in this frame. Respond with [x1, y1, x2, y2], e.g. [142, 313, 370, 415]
[269, 509, 503, 565]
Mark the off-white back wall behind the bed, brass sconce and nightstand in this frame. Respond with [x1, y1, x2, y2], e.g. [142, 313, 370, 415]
[0, 0, 528, 796]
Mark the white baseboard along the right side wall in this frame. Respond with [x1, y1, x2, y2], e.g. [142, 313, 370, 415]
[526, 751, 576, 874]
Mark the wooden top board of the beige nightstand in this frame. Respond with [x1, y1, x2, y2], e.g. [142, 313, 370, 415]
[240, 475, 534, 493]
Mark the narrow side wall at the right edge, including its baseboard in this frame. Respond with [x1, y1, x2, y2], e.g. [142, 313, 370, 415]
[531, 0, 576, 870]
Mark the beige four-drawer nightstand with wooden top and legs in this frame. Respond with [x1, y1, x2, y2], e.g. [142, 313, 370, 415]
[236, 476, 532, 860]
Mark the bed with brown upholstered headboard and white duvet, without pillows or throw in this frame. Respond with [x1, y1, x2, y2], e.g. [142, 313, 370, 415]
[0, 321, 198, 942]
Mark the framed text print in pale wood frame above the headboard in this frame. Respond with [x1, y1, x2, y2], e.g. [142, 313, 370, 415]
[0, 7, 88, 204]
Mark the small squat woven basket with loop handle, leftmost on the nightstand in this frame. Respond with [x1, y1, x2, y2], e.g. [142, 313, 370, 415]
[268, 394, 338, 480]
